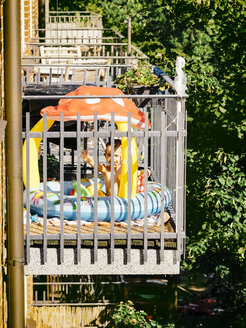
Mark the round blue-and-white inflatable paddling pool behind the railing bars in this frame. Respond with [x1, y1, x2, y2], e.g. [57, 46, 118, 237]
[24, 179, 171, 222]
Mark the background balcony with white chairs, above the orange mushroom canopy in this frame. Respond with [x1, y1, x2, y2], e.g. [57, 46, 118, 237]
[22, 12, 147, 87]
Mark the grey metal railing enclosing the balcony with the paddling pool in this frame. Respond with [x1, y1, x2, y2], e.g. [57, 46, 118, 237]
[23, 93, 186, 273]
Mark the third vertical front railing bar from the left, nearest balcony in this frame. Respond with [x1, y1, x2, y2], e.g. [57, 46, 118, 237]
[60, 113, 64, 263]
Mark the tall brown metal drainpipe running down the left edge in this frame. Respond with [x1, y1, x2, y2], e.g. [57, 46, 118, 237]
[4, 0, 25, 328]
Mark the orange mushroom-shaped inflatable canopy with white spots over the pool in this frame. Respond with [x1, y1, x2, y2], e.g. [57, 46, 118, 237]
[41, 85, 151, 129]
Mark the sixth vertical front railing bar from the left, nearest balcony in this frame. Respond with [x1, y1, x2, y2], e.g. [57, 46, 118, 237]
[110, 113, 117, 263]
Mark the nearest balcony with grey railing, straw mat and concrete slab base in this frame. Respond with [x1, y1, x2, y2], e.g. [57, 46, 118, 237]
[23, 89, 186, 274]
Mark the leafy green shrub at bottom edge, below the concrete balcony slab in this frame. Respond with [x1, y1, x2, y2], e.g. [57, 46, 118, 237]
[112, 301, 168, 328]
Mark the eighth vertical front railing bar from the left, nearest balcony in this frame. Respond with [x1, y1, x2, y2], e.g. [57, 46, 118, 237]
[144, 111, 149, 262]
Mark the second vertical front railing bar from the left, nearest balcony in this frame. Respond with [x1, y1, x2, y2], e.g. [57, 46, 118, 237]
[43, 114, 47, 263]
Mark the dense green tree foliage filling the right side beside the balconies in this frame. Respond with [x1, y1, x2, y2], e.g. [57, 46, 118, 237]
[51, 0, 246, 290]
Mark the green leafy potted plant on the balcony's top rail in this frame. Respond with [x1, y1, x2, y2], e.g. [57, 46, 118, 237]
[114, 62, 165, 93]
